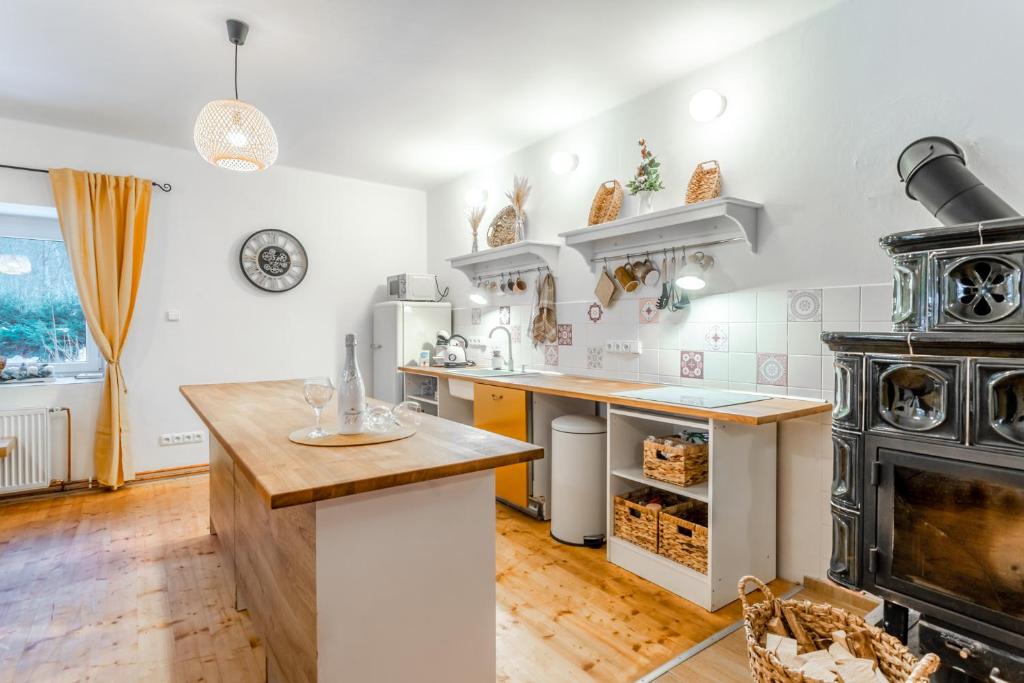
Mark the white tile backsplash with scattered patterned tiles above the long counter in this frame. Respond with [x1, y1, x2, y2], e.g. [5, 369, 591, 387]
[453, 285, 891, 399]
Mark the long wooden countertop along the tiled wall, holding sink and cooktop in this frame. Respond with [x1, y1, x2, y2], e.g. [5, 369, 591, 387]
[399, 366, 831, 425]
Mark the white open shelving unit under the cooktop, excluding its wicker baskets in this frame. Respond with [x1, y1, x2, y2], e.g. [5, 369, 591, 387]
[607, 408, 776, 611]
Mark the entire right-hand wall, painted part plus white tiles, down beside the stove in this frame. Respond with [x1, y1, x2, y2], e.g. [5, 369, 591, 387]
[427, 0, 1024, 581]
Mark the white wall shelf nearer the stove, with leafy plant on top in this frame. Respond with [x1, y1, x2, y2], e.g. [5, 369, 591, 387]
[558, 197, 762, 259]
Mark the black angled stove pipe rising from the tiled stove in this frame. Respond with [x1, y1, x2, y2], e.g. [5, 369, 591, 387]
[896, 137, 1020, 225]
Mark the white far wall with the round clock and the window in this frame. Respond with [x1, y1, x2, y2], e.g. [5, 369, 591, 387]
[0, 120, 426, 478]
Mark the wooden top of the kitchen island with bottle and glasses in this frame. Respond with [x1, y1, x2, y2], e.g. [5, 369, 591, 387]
[180, 380, 544, 508]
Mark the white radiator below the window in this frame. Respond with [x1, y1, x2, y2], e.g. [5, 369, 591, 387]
[0, 408, 53, 494]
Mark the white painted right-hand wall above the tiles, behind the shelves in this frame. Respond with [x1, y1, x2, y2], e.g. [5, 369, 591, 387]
[428, 0, 1024, 305]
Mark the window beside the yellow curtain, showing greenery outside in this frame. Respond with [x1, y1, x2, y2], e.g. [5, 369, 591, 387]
[0, 210, 102, 374]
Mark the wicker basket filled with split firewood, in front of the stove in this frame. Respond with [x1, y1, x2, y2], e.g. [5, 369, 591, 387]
[739, 577, 939, 683]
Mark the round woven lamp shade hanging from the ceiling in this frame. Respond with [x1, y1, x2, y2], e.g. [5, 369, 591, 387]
[195, 99, 278, 172]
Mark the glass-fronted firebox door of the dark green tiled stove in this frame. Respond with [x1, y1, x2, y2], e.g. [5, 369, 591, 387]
[868, 445, 1024, 651]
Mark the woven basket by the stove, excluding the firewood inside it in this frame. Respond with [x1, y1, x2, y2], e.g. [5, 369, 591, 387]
[739, 577, 939, 683]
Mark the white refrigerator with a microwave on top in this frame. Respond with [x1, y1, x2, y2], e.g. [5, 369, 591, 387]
[370, 301, 452, 403]
